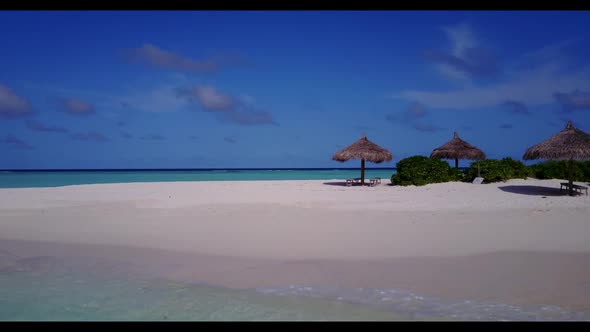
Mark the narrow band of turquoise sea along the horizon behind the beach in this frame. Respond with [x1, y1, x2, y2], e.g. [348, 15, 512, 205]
[0, 168, 395, 188]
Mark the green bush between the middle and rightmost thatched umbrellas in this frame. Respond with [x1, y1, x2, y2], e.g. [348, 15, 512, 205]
[465, 158, 533, 183]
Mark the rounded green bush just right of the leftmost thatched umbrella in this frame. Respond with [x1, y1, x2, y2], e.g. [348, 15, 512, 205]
[391, 156, 463, 186]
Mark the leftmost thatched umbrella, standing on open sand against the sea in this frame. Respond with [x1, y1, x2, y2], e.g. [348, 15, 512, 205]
[332, 135, 393, 185]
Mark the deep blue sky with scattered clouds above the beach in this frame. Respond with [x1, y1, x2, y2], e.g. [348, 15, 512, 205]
[0, 11, 590, 169]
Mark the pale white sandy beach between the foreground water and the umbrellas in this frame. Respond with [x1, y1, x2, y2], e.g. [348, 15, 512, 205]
[0, 180, 590, 310]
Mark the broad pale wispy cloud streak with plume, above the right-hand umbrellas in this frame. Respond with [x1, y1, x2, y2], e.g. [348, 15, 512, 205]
[392, 25, 590, 114]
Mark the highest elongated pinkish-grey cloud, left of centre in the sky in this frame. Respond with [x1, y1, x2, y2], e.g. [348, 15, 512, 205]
[126, 43, 251, 74]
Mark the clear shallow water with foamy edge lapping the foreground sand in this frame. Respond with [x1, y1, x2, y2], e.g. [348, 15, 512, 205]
[0, 256, 590, 321]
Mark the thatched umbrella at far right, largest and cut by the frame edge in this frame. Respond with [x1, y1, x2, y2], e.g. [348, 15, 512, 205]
[522, 121, 590, 196]
